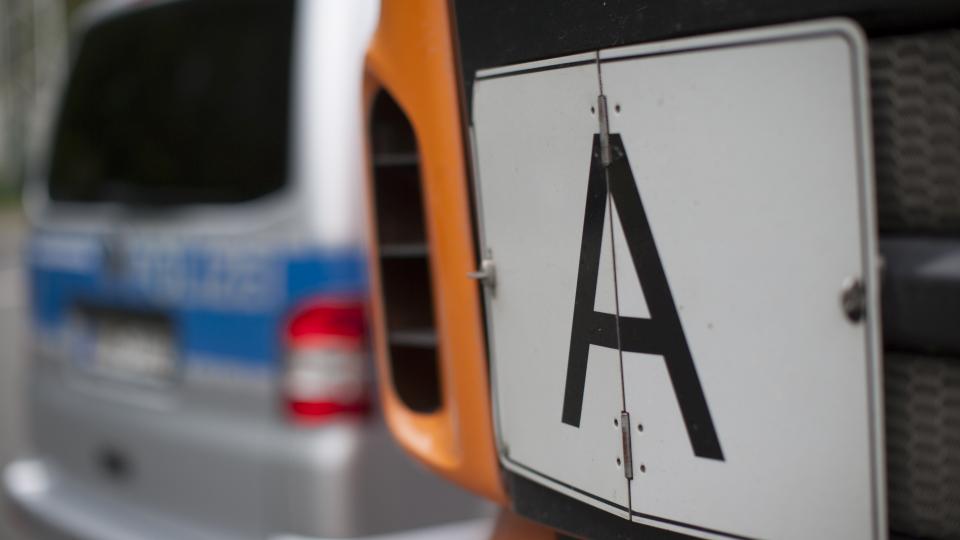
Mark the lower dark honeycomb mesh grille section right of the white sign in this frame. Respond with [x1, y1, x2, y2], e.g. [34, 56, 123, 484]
[885, 353, 960, 539]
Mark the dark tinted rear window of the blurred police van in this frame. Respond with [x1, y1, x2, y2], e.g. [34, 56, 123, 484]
[48, 0, 293, 205]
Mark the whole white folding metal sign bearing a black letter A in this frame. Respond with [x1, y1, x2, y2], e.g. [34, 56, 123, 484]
[473, 21, 885, 539]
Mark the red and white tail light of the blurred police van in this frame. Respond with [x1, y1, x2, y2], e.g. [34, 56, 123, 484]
[281, 299, 370, 424]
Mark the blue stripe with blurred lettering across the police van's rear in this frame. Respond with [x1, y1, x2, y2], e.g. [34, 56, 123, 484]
[28, 234, 366, 367]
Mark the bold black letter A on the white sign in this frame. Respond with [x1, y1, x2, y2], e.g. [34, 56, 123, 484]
[563, 134, 723, 461]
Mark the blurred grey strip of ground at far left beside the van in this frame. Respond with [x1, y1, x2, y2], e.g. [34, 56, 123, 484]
[0, 208, 28, 540]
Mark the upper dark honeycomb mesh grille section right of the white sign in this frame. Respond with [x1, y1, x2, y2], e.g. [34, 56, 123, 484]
[870, 31, 960, 234]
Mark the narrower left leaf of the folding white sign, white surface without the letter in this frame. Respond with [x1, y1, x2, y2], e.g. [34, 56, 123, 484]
[477, 55, 628, 517]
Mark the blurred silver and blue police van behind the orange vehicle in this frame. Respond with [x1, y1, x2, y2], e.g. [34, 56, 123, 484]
[4, 0, 488, 540]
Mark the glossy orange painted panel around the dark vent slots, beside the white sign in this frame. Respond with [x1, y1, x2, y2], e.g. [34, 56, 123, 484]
[365, 0, 506, 503]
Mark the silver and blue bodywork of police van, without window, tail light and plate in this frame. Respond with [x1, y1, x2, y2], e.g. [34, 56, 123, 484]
[3, 0, 486, 540]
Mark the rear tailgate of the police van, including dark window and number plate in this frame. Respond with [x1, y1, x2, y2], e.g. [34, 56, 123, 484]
[29, 1, 298, 537]
